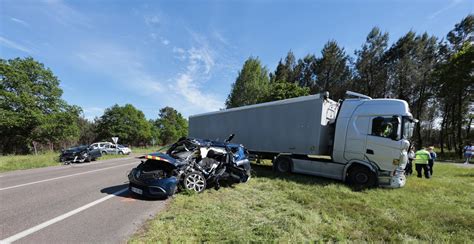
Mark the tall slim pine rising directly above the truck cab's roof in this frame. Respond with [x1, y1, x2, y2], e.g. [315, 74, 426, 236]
[354, 27, 388, 97]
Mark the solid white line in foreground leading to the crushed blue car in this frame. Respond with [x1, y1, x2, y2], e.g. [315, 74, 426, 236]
[0, 188, 128, 244]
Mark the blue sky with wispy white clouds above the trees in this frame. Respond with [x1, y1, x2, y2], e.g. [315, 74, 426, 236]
[0, 0, 474, 119]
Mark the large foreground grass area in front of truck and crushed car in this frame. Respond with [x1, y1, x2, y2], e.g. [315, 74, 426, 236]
[130, 164, 474, 243]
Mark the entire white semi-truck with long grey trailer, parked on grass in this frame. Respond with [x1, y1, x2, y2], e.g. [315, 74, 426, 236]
[189, 91, 417, 188]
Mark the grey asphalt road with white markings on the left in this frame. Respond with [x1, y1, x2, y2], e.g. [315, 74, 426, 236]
[0, 157, 167, 243]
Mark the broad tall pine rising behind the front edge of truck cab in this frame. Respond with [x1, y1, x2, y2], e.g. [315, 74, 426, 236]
[387, 31, 439, 147]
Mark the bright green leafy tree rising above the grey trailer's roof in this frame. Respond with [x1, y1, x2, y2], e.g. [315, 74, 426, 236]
[225, 57, 269, 108]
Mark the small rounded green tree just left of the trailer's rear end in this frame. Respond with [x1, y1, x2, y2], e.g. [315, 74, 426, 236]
[155, 107, 188, 145]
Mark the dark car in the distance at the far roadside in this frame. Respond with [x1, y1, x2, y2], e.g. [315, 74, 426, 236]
[59, 145, 102, 164]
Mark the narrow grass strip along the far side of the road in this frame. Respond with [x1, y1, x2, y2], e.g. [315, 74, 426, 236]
[0, 152, 128, 172]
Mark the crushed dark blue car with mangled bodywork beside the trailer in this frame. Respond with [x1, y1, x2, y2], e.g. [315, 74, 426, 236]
[128, 135, 250, 198]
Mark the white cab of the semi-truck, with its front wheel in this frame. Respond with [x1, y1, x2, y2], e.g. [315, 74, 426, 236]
[332, 96, 416, 187]
